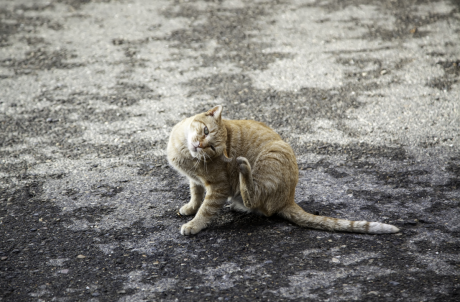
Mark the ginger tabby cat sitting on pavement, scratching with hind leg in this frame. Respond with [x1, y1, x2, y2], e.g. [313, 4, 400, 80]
[167, 105, 399, 235]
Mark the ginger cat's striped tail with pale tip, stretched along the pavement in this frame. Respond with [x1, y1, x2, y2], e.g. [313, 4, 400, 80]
[278, 203, 399, 234]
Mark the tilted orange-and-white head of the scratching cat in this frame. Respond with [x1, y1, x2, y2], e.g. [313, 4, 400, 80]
[187, 105, 232, 160]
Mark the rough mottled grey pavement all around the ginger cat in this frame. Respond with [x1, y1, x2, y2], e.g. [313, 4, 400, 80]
[0, 0, 460, 301]
